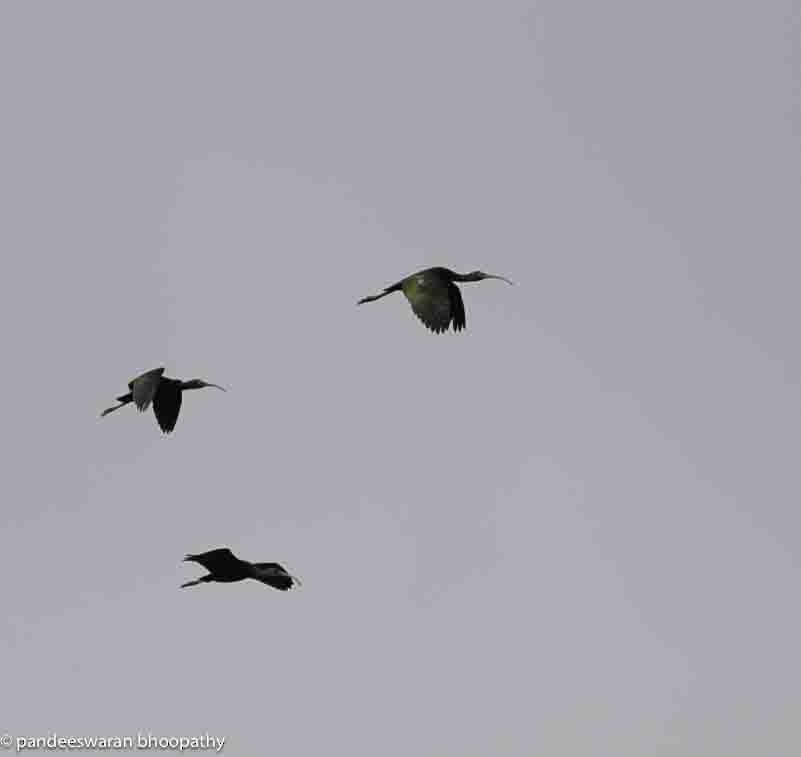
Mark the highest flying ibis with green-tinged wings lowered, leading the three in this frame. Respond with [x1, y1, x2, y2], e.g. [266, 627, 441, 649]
[356, 267, 513, 334]
